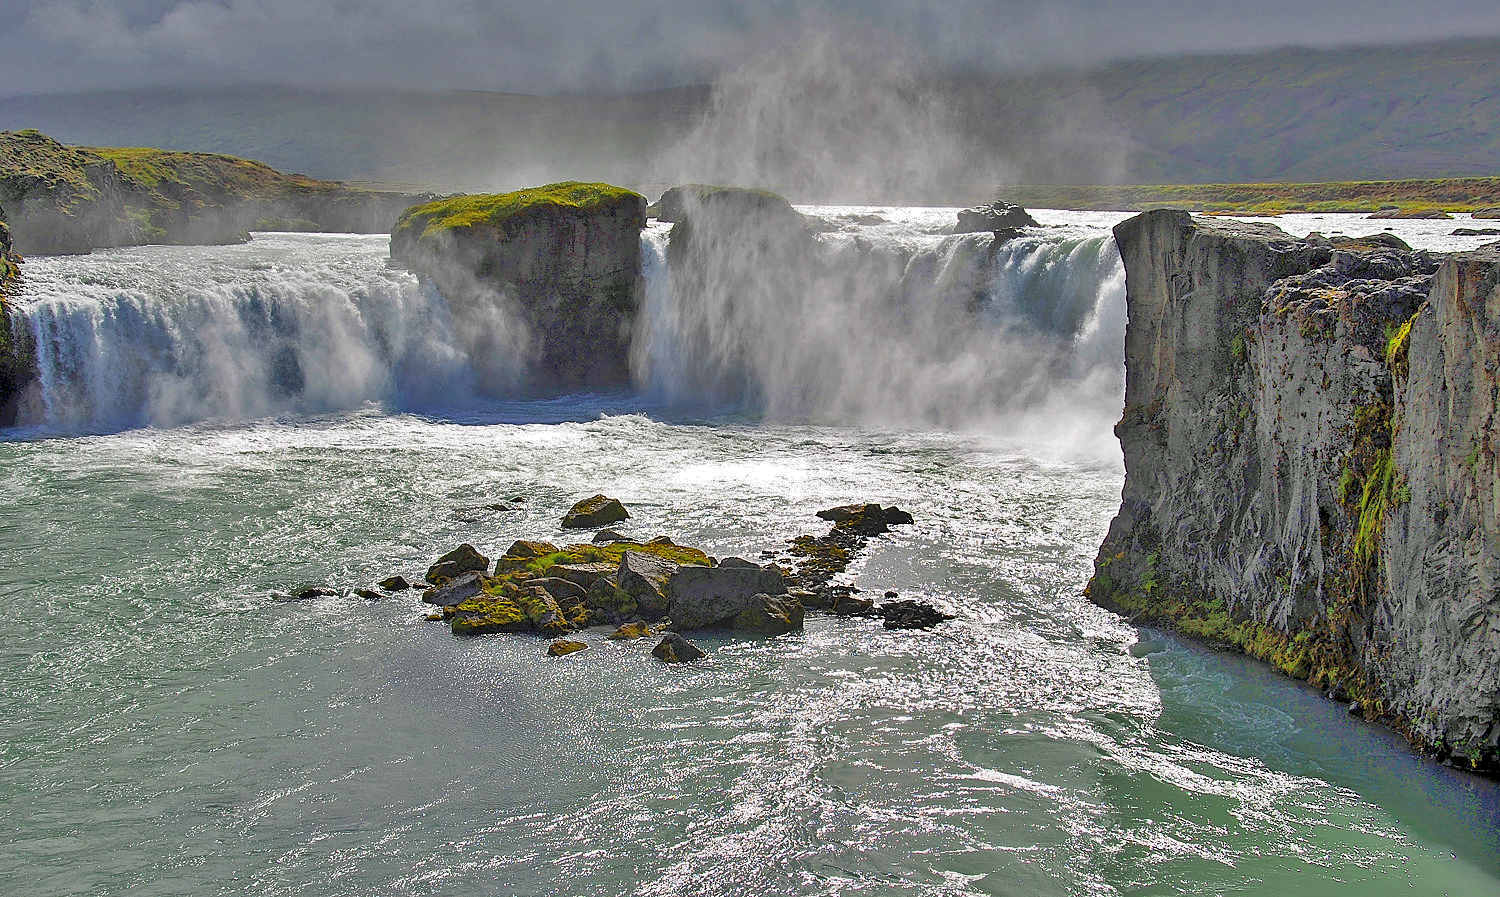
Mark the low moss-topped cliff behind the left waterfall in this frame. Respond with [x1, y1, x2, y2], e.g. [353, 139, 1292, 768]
[0, 131, 431, 255]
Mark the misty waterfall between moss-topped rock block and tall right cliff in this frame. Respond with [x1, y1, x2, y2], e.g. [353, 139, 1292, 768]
[633, 210, 1125, 432]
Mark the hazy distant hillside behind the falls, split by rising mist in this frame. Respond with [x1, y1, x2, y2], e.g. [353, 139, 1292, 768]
[0, 39, 1500, 191]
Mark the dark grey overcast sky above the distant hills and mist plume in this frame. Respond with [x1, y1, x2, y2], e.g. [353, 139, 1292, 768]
[0, 0, 1500, 96]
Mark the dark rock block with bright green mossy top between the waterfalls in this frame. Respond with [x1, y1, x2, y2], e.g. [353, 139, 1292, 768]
[390, 183, 645, 393]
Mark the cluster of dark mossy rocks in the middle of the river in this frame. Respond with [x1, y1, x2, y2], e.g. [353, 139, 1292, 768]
[291, 495, 951, 663]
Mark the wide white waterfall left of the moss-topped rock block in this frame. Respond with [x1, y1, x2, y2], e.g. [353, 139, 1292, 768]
[15, 237, 474, 431]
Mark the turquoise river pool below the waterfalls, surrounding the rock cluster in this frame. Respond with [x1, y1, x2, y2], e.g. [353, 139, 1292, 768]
[0, 414, 1500, 896]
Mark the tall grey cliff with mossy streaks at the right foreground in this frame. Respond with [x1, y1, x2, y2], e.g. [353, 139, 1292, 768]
[1089, 212, 1500, 771]
